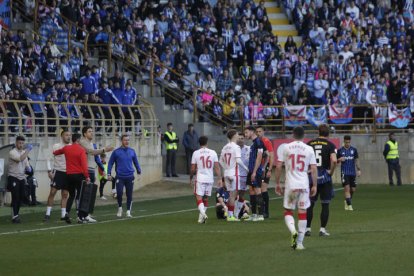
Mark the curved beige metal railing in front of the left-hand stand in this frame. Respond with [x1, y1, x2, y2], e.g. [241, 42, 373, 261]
[0, 100, 159, 144]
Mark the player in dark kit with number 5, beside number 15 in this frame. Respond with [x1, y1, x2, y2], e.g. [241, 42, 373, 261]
[305, 124, 336, 236]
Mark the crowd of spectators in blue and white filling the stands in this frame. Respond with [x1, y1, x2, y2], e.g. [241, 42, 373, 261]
[0, 0, 414, 130]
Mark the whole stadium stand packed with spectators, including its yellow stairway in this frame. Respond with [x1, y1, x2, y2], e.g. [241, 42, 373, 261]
[0, 0, 414, 136]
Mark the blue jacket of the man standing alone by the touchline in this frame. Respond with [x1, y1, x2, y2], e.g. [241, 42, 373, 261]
[108, 147, 141, 179]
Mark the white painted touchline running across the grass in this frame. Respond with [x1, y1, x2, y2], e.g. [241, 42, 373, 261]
[0, 188, 344, 236]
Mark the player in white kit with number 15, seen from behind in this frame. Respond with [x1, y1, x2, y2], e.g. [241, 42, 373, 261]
[275, 127, 318, 250]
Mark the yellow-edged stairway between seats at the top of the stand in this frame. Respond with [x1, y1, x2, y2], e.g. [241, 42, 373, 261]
[254, 0, 302, 47]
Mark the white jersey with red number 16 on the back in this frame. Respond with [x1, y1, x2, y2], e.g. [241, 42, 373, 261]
[191, 148, 218, 183]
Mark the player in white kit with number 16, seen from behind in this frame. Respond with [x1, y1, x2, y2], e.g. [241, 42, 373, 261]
[190, 136, 223, 224]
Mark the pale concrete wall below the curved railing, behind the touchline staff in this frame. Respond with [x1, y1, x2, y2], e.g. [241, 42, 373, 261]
[1, 137, 162, 201]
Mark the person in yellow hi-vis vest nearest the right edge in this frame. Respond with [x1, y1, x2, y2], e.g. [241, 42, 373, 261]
[383, 132, 402, 186]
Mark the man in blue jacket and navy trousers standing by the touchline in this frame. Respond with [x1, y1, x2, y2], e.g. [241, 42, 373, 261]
[108, 135, 141, 218]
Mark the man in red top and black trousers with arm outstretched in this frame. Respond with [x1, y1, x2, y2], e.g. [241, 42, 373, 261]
[53, 133, 90, 223]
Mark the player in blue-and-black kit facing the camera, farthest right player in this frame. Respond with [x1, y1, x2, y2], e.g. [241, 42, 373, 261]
[337, 135, 361, 211]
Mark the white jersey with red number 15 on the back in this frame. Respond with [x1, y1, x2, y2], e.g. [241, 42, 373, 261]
[278, 141, 316, 189]
